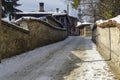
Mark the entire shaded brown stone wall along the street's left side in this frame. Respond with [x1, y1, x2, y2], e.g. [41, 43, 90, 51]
[0, 19, 67, 59]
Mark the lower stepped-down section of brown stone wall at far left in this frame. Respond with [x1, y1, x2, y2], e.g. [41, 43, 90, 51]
[0, 21, 29, 58]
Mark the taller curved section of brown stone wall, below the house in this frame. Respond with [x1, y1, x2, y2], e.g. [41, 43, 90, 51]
[23, 19, 67, 47]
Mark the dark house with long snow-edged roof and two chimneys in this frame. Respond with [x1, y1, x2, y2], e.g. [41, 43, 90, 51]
[15, 3, 79, 35]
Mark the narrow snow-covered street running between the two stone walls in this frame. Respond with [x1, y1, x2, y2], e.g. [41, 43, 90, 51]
[0, 36, 119, 80]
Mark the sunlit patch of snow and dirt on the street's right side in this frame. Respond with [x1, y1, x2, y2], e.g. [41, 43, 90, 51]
[64, 38, 118, 80]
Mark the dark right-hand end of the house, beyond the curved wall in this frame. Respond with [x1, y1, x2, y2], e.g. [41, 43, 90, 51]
[53, 13, 79, 36]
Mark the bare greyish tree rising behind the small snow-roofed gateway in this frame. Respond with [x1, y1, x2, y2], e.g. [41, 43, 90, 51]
[78, 0, 98, 22]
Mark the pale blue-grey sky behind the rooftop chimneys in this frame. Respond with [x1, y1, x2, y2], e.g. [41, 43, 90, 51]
[17, 0, 77, 16]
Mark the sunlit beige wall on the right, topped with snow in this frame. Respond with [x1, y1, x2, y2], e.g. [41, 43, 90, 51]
[93, 15, 120, 77]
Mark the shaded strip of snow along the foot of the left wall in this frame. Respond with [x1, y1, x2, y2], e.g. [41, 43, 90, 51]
[0, 37, 72, 77]
